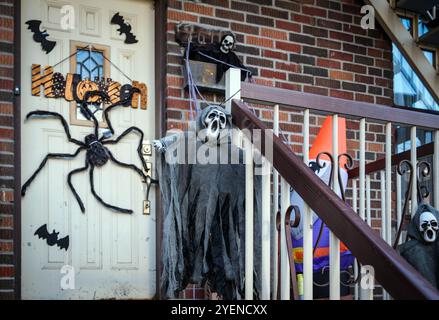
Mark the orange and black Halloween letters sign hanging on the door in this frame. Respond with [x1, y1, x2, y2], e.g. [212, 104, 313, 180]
[32, 64, 148, 109]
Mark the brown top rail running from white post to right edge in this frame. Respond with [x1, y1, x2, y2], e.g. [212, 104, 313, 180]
[241, 82, 439, 129]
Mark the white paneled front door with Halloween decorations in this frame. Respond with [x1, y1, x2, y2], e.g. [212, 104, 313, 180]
[21, 0, 156, 299]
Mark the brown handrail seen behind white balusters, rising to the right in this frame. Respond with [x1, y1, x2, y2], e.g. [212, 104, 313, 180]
[348, 142, 434, 179]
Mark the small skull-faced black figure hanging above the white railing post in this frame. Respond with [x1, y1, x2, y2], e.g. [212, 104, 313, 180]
[189, 33, 252, 82]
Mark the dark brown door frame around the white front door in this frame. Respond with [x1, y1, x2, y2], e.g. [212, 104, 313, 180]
[13, 0, 168, 300]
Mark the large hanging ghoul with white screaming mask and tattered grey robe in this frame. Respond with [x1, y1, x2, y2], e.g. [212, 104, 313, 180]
[153, 105, 261, 300]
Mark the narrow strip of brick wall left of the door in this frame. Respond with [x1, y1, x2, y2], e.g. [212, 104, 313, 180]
[0, 0, 15, 300]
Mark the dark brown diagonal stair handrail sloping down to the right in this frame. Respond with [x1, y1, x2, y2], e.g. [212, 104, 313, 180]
[232, 100, 439, 300]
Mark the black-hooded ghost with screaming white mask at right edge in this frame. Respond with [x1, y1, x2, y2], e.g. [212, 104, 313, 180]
[398, 204, 439, 289]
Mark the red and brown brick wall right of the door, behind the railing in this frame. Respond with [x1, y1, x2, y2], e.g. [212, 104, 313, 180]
[166, 0, 393, 298]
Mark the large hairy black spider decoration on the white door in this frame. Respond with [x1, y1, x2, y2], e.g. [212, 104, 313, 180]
[21, 87, 157, 213]
